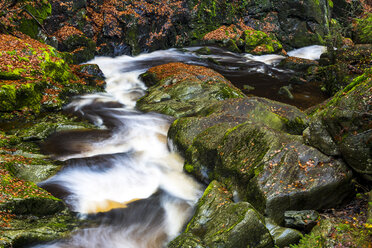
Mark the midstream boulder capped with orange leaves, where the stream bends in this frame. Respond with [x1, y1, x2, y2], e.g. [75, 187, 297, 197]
[137, 63, 244, 117]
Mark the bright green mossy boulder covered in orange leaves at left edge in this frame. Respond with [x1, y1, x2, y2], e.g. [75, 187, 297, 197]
[0, 34, 104, 119]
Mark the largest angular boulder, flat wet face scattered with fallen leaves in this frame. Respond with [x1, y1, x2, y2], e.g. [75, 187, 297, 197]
[190, 122, 351, 223]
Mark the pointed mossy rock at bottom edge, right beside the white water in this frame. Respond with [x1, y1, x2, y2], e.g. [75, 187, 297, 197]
[168, 181, 274, 248]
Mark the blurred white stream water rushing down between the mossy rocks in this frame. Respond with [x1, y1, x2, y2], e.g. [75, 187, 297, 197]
[37, 47, 326, 248]
